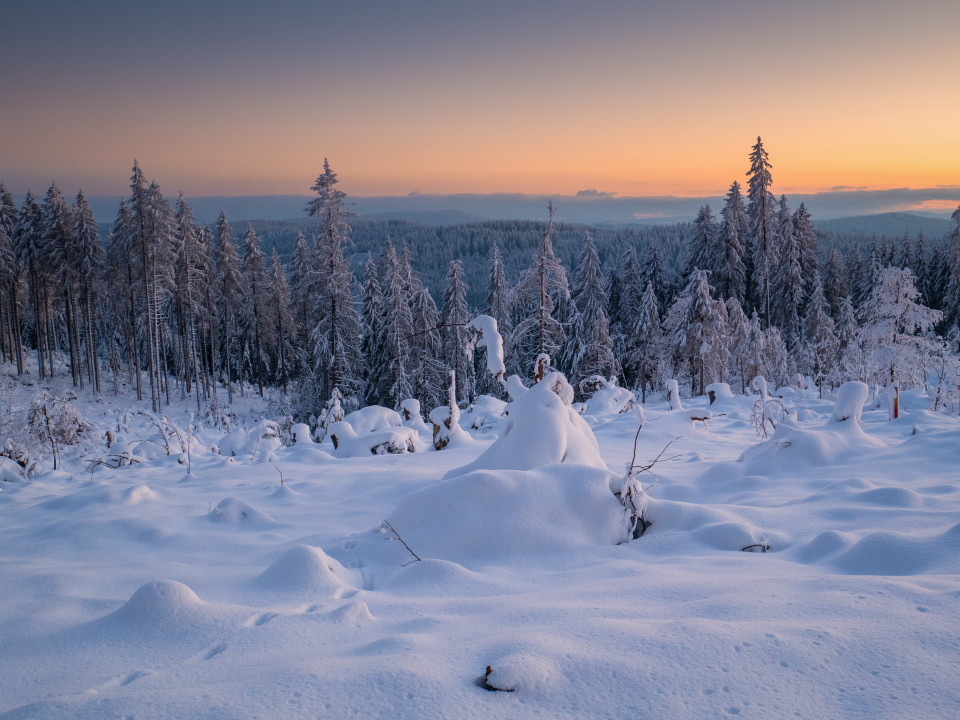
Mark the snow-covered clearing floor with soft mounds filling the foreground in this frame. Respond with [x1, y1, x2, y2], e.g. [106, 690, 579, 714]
[0, 372, 960, 719]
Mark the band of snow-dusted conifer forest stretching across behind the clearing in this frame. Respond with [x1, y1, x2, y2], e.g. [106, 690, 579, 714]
[0, 138, 960, 419]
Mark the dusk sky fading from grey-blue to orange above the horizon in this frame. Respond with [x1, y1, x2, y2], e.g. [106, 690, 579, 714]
[0, 0, 960, 195]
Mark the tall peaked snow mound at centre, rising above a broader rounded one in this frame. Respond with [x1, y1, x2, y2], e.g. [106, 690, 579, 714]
[446, 373, 607, 478]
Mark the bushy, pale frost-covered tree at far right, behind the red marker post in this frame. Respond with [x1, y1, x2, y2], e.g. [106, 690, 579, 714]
[859, 267, 943, 389]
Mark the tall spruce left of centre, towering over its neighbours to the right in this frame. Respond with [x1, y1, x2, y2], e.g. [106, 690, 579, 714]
[307, 159, 362, 402]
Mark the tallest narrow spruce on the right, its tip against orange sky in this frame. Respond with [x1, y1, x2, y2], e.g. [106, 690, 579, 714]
[747, 137, 779, 326]
